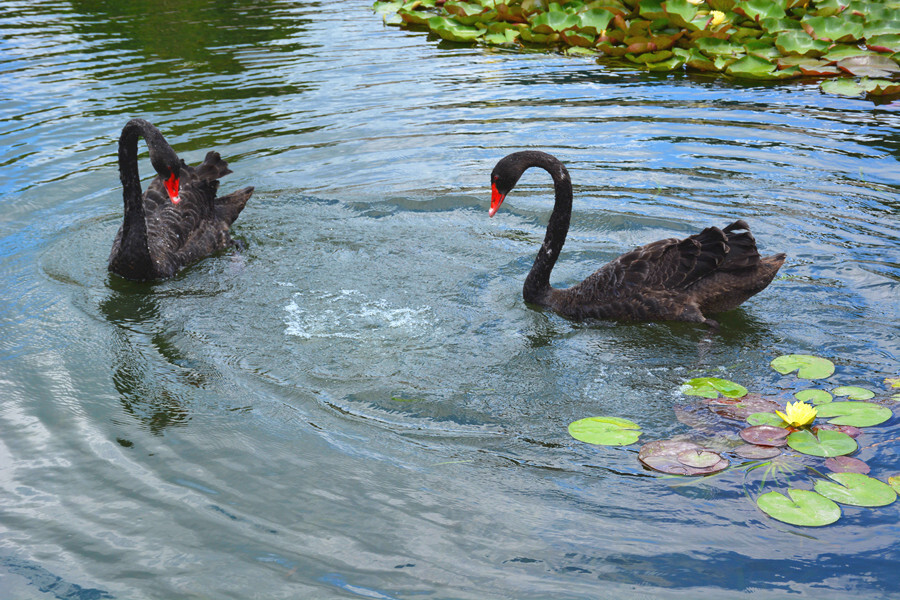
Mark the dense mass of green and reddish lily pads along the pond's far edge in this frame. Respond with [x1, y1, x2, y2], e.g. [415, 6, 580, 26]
[375, 0, 900, 96]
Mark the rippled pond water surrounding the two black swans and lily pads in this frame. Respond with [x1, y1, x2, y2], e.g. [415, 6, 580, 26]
[0, 0, 900, 600]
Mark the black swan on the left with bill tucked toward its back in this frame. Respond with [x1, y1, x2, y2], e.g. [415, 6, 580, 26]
[109, 119, 253, 281]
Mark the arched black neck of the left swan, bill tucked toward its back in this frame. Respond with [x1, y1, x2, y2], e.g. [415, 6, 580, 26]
[110, 119, 177, 276]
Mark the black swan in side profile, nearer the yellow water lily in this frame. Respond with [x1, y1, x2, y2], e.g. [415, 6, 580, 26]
[489, 151, 785, 327]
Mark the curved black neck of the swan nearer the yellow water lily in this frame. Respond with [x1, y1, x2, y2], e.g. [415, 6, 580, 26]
[522, 152, 572, 304]
